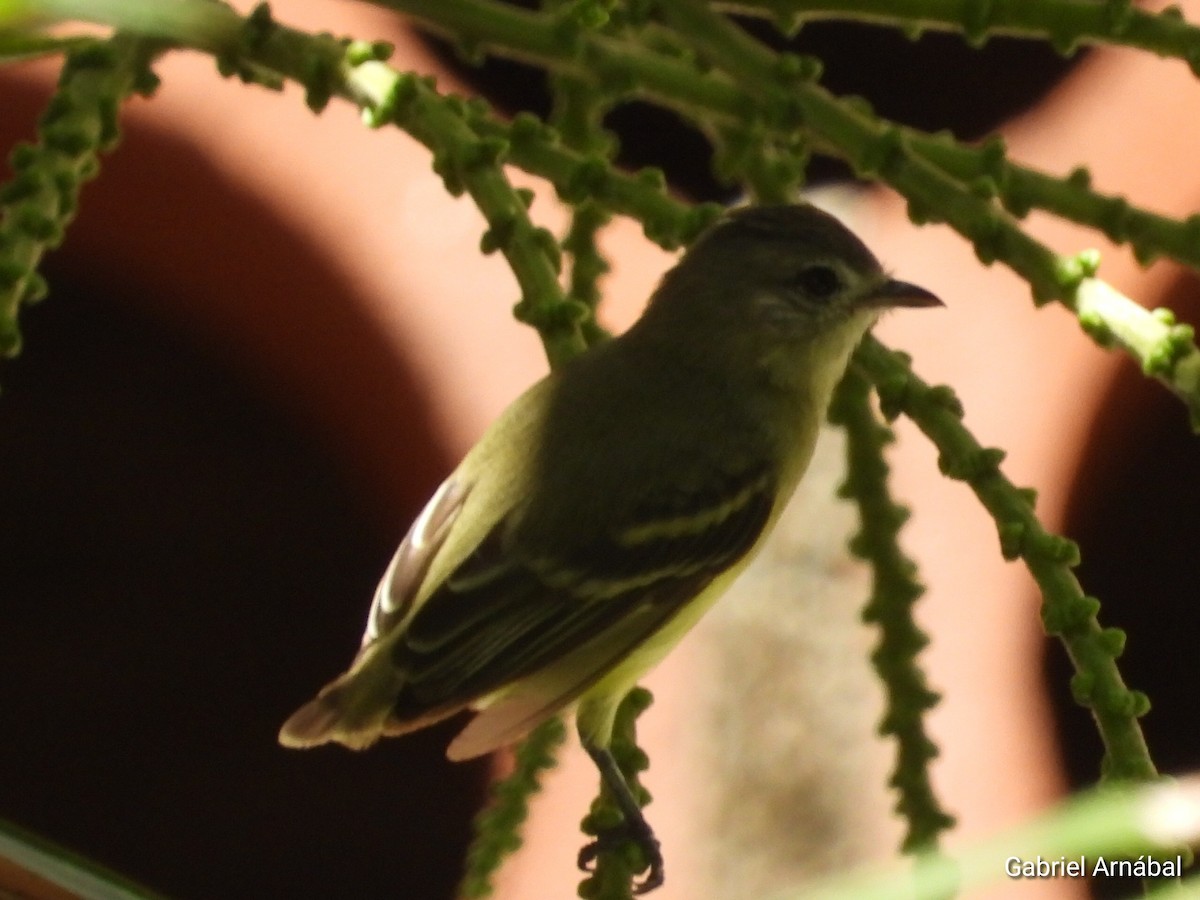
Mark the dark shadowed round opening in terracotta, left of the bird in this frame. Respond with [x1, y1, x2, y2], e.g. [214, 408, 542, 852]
[0, 77, 487, 898]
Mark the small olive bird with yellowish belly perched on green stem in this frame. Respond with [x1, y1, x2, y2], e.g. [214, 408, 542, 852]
[280, 204, 941, 893]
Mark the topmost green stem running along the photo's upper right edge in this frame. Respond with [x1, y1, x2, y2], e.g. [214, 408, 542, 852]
[718, 0, 1200, 66]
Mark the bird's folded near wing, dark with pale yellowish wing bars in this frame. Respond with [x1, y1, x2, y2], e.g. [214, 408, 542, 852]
[384, 460, 776, 758]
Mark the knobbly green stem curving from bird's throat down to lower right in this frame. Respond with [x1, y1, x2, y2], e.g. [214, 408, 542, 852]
[854, 336, 1157, 781]
